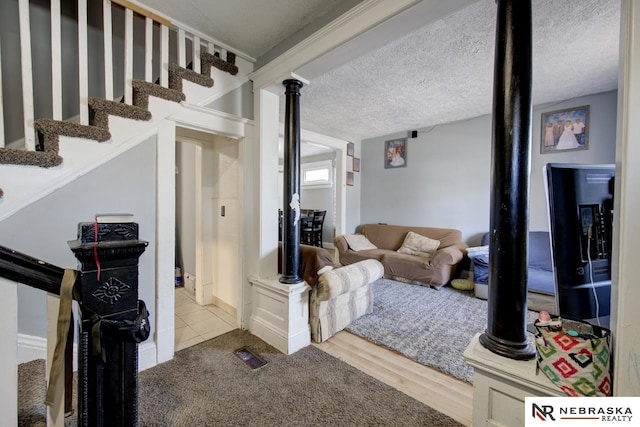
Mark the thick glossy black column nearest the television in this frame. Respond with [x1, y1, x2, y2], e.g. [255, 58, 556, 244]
[480, 0, 535, 360]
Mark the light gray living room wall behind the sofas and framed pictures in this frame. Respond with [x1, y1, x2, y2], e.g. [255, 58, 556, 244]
[356, 91, 617, 245]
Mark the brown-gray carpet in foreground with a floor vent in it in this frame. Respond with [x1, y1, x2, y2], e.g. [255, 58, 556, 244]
[19, 330, 460, 426]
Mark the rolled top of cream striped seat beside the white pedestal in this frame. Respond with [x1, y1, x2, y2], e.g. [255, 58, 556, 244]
[316, 259, 384, 301]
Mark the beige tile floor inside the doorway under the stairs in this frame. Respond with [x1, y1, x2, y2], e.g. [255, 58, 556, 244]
[175, 287, 237, 351]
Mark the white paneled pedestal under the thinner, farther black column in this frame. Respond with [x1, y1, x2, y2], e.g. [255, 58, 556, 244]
[249, 278, 311, 354]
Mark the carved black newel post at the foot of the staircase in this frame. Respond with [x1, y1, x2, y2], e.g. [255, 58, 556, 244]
[69, 222, 149, 427]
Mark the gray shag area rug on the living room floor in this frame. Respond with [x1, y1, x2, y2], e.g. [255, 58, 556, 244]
[346, 279, 537, 383]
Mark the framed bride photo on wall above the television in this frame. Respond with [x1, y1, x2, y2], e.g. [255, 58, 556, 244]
[540, 105, 589, 154]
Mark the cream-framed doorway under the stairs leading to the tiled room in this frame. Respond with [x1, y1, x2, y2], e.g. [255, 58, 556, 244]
[175, 128, 242, 348]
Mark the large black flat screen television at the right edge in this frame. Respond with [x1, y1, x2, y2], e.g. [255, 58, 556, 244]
[545, 163, 615, 327]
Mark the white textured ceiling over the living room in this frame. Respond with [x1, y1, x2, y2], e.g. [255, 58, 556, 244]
[301, 0, 620, 140]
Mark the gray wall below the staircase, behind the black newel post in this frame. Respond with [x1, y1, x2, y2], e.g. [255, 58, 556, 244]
[0, 137, 156, 337]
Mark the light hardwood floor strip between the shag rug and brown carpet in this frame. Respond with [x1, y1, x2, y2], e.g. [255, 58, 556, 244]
[314, 331, 473, 426]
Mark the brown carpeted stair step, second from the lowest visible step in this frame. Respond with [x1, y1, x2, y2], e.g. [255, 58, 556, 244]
[33, 119, 111, 153]
